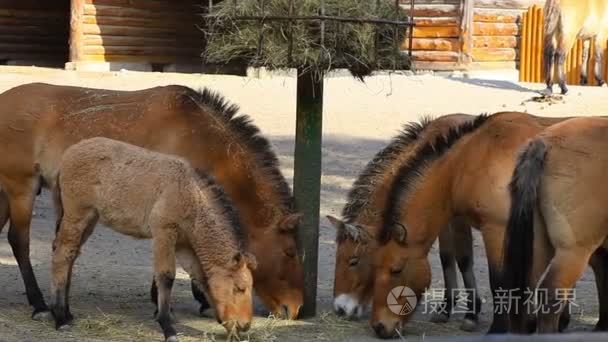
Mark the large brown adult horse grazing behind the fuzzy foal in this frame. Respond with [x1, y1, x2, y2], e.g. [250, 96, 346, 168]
[0, 83, 303, 318]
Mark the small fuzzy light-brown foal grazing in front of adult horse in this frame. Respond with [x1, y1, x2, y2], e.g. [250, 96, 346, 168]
[51, 138, 255, 341]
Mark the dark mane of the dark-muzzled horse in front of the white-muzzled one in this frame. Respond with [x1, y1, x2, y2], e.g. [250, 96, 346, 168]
[378, 114, 490, 243]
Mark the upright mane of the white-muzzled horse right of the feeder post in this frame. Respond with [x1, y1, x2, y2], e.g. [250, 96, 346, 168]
[342, 116, 433, 223]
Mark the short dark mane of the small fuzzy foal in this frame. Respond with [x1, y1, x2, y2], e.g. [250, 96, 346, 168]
[195, 168, 247, 249]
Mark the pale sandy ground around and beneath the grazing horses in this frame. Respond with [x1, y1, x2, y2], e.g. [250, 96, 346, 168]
[0, 67, 608, 341]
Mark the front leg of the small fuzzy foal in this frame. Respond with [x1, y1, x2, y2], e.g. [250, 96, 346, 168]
[153, 226, 178, 342]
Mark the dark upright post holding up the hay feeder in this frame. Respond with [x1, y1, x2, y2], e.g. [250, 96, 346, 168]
[293, 70, 323, 318]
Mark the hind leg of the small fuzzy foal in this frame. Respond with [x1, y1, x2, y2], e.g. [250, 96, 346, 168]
[51, 209, 97, 330]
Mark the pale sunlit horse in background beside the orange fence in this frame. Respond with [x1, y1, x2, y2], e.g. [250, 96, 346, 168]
[543, 0, 608, 94]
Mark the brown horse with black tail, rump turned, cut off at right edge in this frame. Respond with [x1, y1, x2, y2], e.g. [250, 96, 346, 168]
[505, 118, 608, 333]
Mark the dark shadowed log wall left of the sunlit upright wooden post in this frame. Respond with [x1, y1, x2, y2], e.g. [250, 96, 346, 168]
[0, 0, 70, 66]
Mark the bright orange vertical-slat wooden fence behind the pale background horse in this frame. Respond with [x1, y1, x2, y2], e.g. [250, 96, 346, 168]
[519, 5, 608, 85]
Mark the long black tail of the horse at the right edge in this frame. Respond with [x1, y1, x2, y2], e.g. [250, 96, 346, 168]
[503, 139, 547, 332]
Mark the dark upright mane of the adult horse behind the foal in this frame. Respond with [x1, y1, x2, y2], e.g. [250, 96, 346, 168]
[190, 88, 294, 210]
